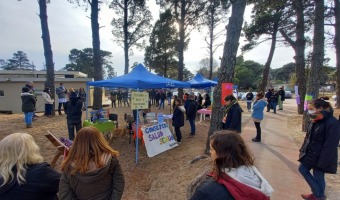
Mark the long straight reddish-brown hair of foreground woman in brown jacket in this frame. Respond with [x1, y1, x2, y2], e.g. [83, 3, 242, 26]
[61, 126, 119, 174]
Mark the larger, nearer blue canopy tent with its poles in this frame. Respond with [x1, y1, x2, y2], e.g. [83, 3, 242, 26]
[86, 64, 190, 164]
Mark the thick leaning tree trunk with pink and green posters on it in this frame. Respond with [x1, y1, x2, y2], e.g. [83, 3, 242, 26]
[204, 0, 246, 154]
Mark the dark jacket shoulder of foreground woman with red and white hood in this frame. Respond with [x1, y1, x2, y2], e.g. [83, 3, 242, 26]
[190, 177, 234, 200]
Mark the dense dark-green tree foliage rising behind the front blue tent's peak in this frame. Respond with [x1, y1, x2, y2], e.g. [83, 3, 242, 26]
[144, 10, 179, 77]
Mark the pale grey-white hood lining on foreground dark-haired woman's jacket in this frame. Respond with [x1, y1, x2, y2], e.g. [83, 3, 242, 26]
[224, 166, 274, 196]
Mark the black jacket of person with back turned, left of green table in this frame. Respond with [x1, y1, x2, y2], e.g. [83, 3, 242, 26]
[65, 97, 83, 123]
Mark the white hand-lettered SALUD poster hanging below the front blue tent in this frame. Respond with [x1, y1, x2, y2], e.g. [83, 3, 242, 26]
[142, 123, 178, 157]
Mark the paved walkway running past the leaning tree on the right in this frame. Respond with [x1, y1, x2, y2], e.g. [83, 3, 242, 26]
[242, 101, 310, 200]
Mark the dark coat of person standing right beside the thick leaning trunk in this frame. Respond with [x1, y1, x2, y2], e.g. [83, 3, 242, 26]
[223, 103, 243, 133]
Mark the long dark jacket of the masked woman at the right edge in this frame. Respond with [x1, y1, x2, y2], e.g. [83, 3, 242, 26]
[299, 111, 340, 174]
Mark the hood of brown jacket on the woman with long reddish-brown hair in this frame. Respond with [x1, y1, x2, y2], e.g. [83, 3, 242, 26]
[69, 154, 112, 183]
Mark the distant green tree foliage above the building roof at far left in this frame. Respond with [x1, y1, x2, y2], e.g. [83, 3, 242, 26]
[1, 51, 35, 70]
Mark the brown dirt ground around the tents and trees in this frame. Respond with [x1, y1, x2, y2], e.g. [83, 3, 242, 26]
[0, 102, 340, 200]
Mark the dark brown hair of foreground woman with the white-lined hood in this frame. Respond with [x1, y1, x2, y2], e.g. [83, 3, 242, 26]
[210, 130, 254, 180]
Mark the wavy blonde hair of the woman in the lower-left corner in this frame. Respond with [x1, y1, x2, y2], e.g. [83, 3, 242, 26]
[0, 133, 43, 187]
